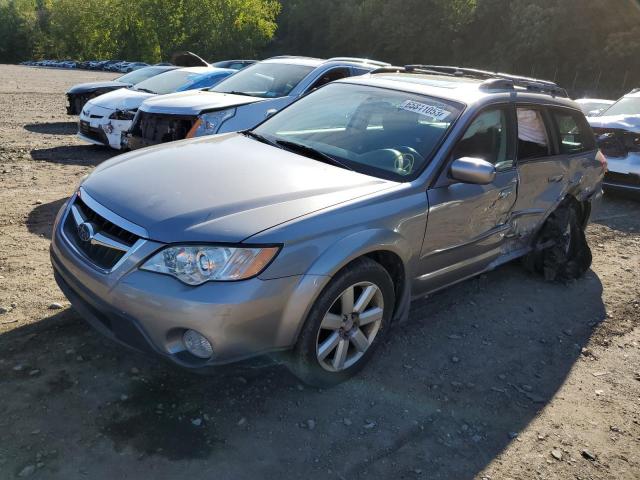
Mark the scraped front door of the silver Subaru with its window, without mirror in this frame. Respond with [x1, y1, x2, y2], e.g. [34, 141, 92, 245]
[414, 105, 518, 294]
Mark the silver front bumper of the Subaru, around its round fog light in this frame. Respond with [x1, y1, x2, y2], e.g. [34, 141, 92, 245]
[51, 202, 314, 368]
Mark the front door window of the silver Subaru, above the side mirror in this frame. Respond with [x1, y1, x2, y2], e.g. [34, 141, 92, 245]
[453, 108, 513, 170]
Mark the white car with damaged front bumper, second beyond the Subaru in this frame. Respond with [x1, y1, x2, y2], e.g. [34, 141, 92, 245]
[78, 67, 235, 150]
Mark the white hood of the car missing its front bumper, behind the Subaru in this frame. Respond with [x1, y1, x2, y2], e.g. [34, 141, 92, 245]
[141, 90, 264, 115]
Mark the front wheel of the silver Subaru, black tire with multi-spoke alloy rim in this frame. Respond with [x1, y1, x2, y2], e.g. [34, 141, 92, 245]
[287, 258, 395, 387]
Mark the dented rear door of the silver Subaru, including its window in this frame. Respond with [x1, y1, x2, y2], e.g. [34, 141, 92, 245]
[514, 104, 568, 236]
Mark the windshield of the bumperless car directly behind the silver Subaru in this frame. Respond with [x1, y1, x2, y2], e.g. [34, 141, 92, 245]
[211, 63, 313, 98]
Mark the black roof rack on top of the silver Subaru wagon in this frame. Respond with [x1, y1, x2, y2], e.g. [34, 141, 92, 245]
[371, 65, 569, 97]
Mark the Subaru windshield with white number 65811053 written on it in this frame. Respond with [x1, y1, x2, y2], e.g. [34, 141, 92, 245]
[253, 83, 461, 181]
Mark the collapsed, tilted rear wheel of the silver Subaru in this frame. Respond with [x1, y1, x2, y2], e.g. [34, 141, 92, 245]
[523, 199, 592, 282]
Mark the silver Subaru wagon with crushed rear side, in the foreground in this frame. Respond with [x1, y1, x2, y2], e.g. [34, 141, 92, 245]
[51, 66, 606, 385]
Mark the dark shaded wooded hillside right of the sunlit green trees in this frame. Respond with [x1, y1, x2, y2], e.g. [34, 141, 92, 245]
[268, 0, 640, 98]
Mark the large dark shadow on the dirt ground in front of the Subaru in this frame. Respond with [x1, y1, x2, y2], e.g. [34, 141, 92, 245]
[0, 265, 605, 479]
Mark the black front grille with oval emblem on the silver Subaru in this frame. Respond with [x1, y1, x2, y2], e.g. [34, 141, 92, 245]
[63, 197, 140, 270]
